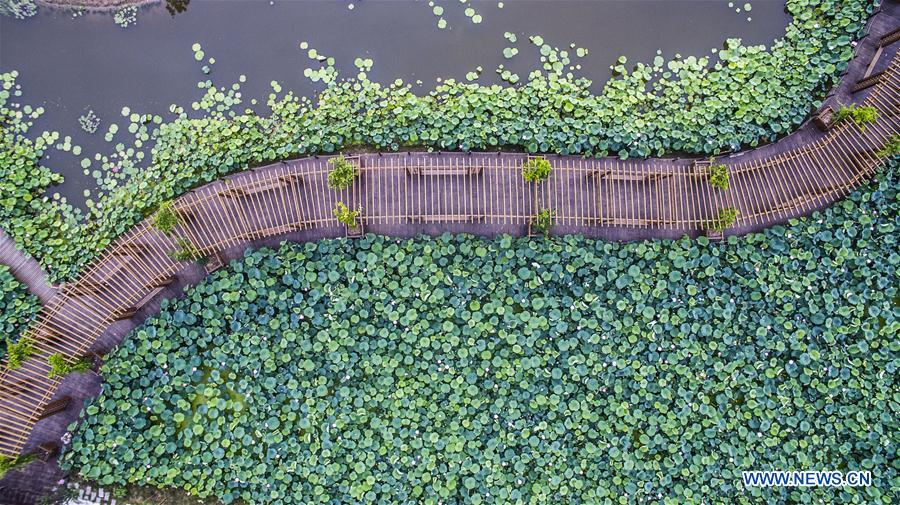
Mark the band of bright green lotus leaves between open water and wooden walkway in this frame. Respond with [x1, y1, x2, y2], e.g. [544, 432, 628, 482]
[4, 0, 875, 281]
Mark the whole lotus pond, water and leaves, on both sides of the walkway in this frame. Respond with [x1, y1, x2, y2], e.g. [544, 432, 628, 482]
[0, 0, 900, 505]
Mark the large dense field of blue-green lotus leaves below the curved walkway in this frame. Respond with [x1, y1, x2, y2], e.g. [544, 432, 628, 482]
[63, 165, 900, 504]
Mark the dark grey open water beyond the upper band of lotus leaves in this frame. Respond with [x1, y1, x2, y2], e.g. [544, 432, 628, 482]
[0, 0, 790, 203]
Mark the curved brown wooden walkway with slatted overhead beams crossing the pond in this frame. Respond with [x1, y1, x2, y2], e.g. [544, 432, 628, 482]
[0, 22, 900, 468]
